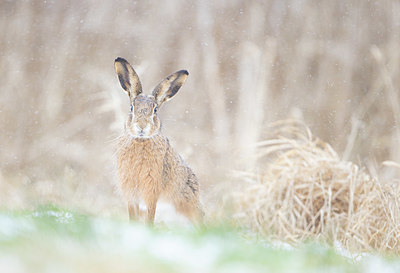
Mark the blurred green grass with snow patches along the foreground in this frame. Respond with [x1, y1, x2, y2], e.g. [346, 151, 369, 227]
[0, 206, 399, 273]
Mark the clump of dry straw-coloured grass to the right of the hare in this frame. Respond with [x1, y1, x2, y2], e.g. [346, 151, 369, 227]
[234, 122, 400, 253]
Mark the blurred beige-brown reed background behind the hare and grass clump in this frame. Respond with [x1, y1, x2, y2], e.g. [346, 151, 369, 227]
[0, 0, 400, 215]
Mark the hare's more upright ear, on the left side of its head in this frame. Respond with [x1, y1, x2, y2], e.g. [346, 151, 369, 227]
[114, 57, 142, 99]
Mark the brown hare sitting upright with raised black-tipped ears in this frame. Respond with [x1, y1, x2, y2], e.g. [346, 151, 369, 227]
[114, 58, 203, 223]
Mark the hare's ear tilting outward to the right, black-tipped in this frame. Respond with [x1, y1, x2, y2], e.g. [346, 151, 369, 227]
[153, 70, 189, 106]
